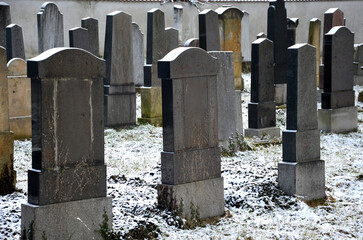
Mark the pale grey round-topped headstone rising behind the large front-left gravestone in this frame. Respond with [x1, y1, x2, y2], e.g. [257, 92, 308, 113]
[37, 2, 64, 54]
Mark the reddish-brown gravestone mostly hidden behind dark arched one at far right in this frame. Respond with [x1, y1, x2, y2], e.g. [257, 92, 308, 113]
[319, 8, 345, 89]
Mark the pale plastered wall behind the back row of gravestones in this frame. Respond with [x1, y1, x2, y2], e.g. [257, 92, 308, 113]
[5, 0, 363, 58]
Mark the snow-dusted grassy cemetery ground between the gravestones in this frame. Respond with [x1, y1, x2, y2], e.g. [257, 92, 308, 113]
[0, 75, 363, 239]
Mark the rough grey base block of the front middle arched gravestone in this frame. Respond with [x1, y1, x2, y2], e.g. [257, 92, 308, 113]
[158, 177, 224, 219]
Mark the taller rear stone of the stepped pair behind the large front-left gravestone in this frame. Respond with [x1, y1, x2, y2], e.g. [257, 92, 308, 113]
[81, 17, 100, 57]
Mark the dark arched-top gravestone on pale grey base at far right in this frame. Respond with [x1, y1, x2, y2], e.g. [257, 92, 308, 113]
[318, 26, 358, 133]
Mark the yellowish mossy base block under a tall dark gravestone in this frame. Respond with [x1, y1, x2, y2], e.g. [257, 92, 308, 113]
[138, 87, 163, 126]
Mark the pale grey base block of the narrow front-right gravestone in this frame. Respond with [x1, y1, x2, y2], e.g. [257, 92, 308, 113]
[278, 160, 325, 201]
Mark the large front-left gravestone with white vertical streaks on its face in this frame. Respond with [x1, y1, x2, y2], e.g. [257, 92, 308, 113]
[21, 48, 112, 239]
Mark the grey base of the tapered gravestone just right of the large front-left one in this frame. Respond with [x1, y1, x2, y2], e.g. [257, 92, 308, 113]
[105, 90, 136, 127]
